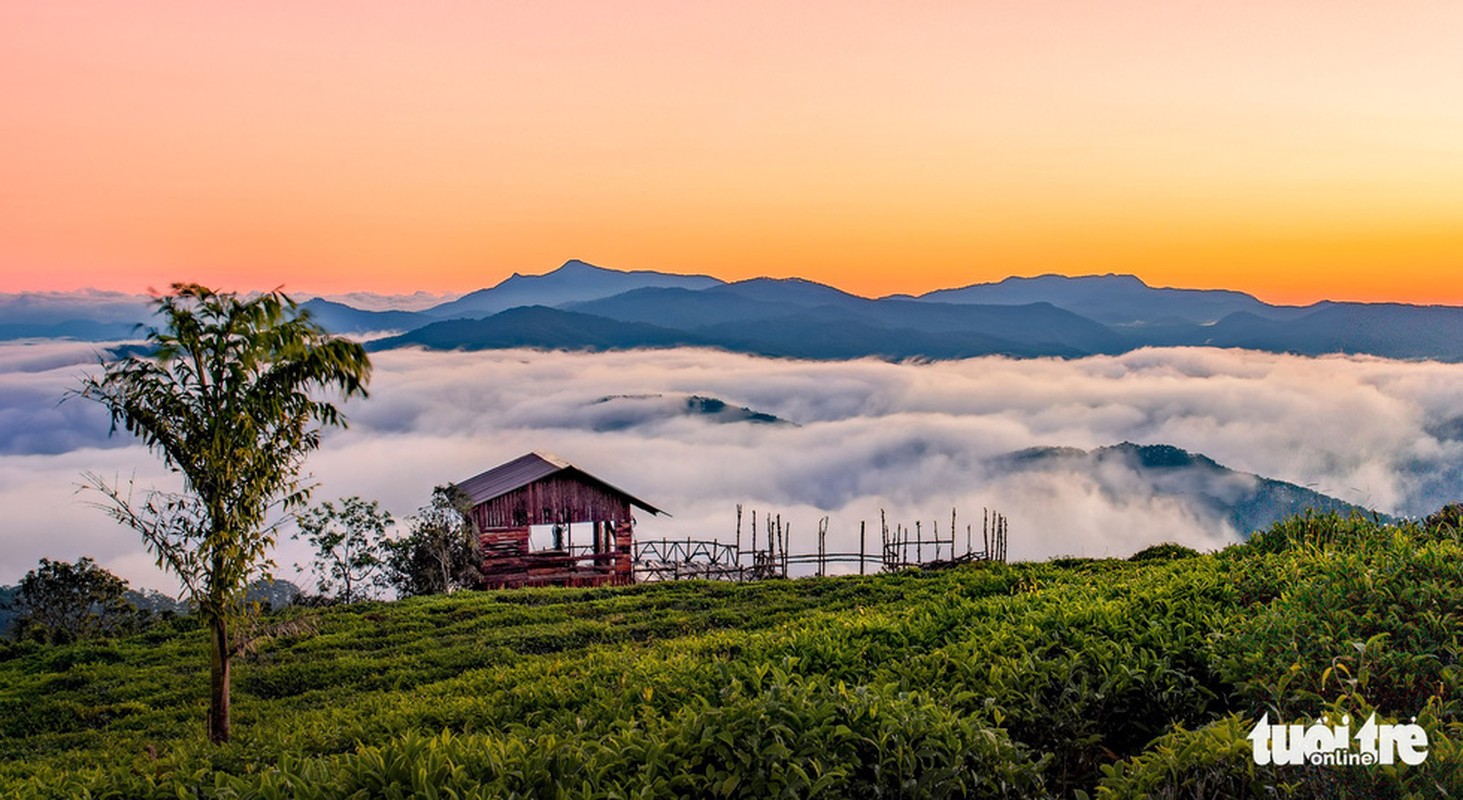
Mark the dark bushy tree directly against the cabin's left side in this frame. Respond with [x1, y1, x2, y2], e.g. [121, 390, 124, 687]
[383, 484, 483, 597]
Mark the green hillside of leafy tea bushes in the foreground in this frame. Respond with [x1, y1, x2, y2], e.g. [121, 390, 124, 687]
[0, 516, 1463, 799]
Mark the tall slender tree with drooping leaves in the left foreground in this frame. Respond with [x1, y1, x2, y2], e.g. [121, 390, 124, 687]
[78, 284, 370, 743]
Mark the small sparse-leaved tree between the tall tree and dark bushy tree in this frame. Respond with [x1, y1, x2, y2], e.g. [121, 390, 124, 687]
[294, 497, 395, 603]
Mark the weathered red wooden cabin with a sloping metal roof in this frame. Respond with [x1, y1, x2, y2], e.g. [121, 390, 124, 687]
[456, 452, 664, 589]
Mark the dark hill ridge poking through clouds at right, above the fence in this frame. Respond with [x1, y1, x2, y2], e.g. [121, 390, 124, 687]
[996, 442, 1390, 535]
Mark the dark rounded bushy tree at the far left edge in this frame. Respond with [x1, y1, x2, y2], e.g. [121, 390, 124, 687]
[13, 557, 132, 644]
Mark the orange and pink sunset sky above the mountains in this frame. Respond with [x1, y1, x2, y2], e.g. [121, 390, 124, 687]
[0, 0, 1463, 304]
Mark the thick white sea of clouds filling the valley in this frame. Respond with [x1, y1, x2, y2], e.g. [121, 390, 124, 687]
[0, 342, 1463, 591]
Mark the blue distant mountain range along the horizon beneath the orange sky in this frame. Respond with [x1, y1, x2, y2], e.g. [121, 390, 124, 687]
[0, 260, 1463, 361]
